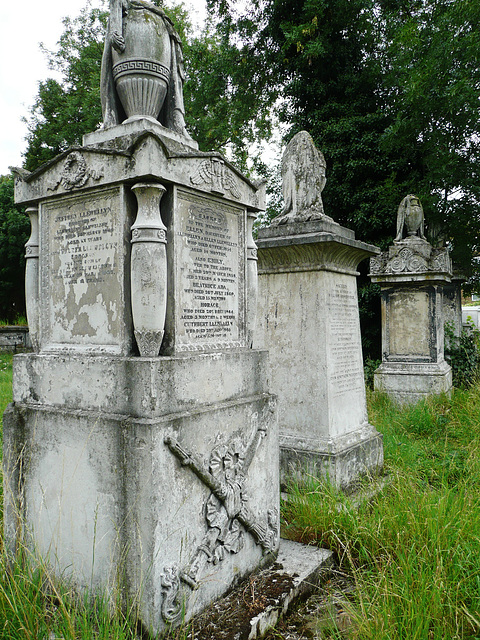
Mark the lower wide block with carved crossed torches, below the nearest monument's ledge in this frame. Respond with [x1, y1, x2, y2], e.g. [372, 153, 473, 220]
[4, 382, 279, 632]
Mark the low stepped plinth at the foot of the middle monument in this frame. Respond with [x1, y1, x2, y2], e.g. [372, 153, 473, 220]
[280, 424, 383, 492]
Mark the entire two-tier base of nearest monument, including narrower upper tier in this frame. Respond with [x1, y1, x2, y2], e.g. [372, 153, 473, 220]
[4, 350, 279, 634]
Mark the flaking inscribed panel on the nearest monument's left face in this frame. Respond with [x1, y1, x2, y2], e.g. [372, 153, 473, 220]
[41, 188, 125, 353]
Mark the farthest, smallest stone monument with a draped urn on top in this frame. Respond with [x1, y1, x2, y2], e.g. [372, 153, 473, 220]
[370, 195, 452, 403]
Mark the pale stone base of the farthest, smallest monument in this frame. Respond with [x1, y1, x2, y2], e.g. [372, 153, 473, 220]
[374, 360, 452, 404]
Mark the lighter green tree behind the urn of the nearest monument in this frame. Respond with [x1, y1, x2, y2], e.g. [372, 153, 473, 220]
[25, 0, 276, 170]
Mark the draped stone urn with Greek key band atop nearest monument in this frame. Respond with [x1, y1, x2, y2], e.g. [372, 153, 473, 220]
[100, 0, 191, 139]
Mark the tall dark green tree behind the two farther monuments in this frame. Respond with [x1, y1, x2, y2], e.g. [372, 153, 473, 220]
[209, 0, 480, 355]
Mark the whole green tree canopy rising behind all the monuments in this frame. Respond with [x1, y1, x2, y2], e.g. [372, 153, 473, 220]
[0, 0, 480, 350]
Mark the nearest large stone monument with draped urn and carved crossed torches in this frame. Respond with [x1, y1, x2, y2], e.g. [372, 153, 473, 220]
[4, 0, 279, 634]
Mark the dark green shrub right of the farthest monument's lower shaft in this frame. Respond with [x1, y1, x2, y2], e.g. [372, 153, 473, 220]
[445, 323, 480, 387]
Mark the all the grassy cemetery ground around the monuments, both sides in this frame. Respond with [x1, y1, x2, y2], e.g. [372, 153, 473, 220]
[0, 354, 480, 640]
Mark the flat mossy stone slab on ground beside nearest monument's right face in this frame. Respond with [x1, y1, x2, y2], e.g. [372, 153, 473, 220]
[184, 540, 334, 640]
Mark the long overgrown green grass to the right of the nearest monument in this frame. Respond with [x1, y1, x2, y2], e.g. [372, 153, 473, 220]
[283, 386, 480, 640]
